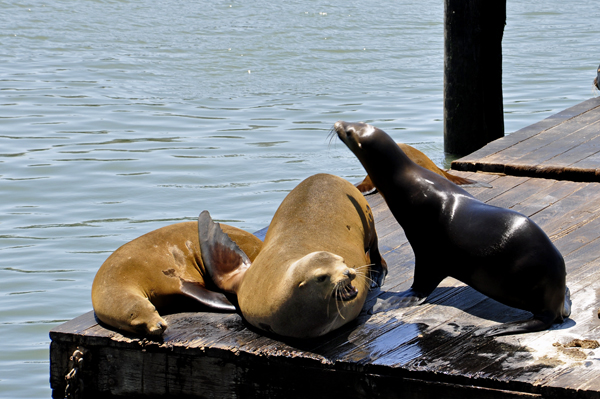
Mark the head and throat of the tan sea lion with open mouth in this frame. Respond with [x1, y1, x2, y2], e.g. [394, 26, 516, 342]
[270, 251, 368, 338]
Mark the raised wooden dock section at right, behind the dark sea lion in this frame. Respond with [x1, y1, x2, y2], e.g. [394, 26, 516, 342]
[452, 97, 600, 182]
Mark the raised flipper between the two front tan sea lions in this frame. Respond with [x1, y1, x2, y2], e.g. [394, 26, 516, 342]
[198, 211, 252, 294]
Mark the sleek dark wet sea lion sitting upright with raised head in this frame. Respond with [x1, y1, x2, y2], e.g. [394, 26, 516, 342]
[334, 121, 571, 336]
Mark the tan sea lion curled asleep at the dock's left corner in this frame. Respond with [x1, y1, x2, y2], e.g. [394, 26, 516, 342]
[92, 222, 262, 335]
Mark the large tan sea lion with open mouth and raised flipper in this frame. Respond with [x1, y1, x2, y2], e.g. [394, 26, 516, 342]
[198, 174, 387, 338]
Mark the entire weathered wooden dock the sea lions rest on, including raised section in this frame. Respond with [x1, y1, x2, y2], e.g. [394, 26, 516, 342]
[50, 99, 600, 399]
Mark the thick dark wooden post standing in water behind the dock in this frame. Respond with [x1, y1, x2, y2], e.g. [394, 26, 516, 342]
[444, 0, 506, 155]
